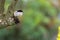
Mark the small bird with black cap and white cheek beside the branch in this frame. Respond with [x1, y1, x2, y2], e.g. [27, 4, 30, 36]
[13, 10, 23, 24]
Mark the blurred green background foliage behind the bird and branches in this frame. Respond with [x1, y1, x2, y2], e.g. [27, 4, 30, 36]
[0, 0, 60, 40]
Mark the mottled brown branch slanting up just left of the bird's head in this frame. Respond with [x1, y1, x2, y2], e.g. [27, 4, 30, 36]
[5, 0, 18, 25]
